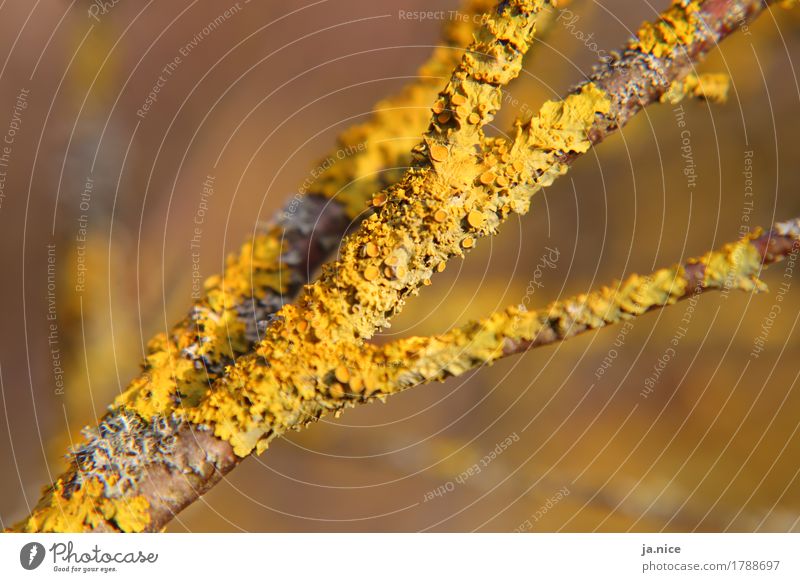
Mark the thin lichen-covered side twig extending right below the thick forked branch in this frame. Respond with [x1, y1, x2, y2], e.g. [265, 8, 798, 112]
[364, 218, 800, 396]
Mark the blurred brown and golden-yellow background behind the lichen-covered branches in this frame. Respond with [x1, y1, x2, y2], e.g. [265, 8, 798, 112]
[0, 0, 800, 531]
